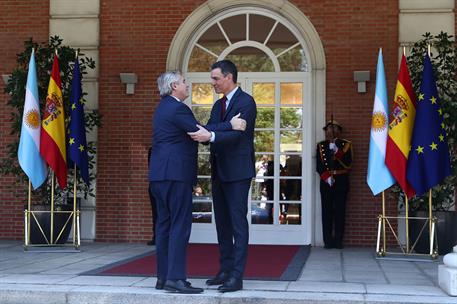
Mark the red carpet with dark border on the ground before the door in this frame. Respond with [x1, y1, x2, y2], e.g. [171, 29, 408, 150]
[91, 244, 309, 281]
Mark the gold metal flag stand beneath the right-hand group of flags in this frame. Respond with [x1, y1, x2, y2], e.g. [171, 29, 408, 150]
[376, 214, 438, 261]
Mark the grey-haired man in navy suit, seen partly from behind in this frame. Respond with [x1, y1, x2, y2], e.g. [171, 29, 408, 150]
[149, 72, 243, 293]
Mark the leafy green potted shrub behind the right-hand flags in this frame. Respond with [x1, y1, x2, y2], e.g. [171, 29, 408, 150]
[401, 32, 457, 255]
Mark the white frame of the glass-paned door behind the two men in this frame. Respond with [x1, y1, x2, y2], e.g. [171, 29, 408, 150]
[186, 72, 315, 244]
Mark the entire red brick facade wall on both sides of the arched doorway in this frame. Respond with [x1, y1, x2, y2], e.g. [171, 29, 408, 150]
[0, 0, 448, 246]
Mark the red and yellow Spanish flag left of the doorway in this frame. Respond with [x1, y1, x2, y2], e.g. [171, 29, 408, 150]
[40, 55, 67, 189]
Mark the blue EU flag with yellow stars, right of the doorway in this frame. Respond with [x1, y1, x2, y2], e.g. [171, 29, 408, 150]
[407, 55, 451, 196]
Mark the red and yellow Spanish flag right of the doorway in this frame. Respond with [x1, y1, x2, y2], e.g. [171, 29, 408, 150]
[385, 55, 416, 197]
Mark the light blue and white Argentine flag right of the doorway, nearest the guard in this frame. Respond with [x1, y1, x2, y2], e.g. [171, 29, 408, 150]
[367, 49, 395, 195]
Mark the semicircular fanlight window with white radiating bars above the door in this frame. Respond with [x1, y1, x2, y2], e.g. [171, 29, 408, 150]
[187, 12, 308, 72]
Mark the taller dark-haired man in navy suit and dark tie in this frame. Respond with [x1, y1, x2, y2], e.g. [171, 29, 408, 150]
[186, 60, 257, 292]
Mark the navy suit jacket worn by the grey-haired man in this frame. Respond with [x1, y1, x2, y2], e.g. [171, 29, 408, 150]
[149, 96, 232, 185]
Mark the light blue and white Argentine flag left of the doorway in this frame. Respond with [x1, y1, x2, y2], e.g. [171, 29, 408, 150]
[17, 50, 47, 189]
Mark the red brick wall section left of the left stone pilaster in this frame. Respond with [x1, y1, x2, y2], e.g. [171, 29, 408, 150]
[0, 0, 49, 239]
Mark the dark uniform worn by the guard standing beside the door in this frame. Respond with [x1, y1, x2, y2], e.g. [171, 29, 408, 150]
[316, 138, 352, 248]
